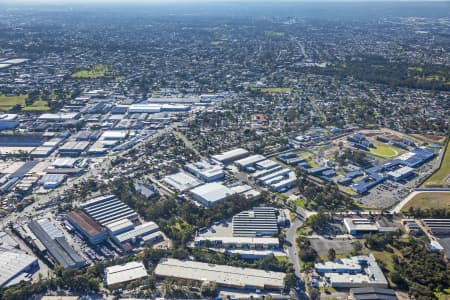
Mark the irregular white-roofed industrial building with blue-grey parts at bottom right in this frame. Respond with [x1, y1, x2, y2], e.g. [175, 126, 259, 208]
[314, 253, 388, 288]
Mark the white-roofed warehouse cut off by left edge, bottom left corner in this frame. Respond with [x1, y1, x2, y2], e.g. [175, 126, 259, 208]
[0, 248, 39, 288]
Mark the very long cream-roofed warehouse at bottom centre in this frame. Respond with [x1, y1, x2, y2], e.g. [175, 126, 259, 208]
[155, 258, 286, 289]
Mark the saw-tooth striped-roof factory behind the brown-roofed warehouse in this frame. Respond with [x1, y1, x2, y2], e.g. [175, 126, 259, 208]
[80, 195, 138, 226]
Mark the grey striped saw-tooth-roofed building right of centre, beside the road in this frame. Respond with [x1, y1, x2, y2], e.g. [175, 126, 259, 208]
[232, 207, 278, 237]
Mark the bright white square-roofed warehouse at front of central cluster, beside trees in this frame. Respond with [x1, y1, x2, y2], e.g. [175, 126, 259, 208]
[190, 182, 235, 206]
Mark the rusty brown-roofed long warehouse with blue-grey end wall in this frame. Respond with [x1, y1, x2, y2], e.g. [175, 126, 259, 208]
[67, 210, 106, 245]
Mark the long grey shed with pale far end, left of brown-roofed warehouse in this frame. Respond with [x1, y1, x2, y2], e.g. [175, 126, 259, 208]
[28, 219, 86, 269]
